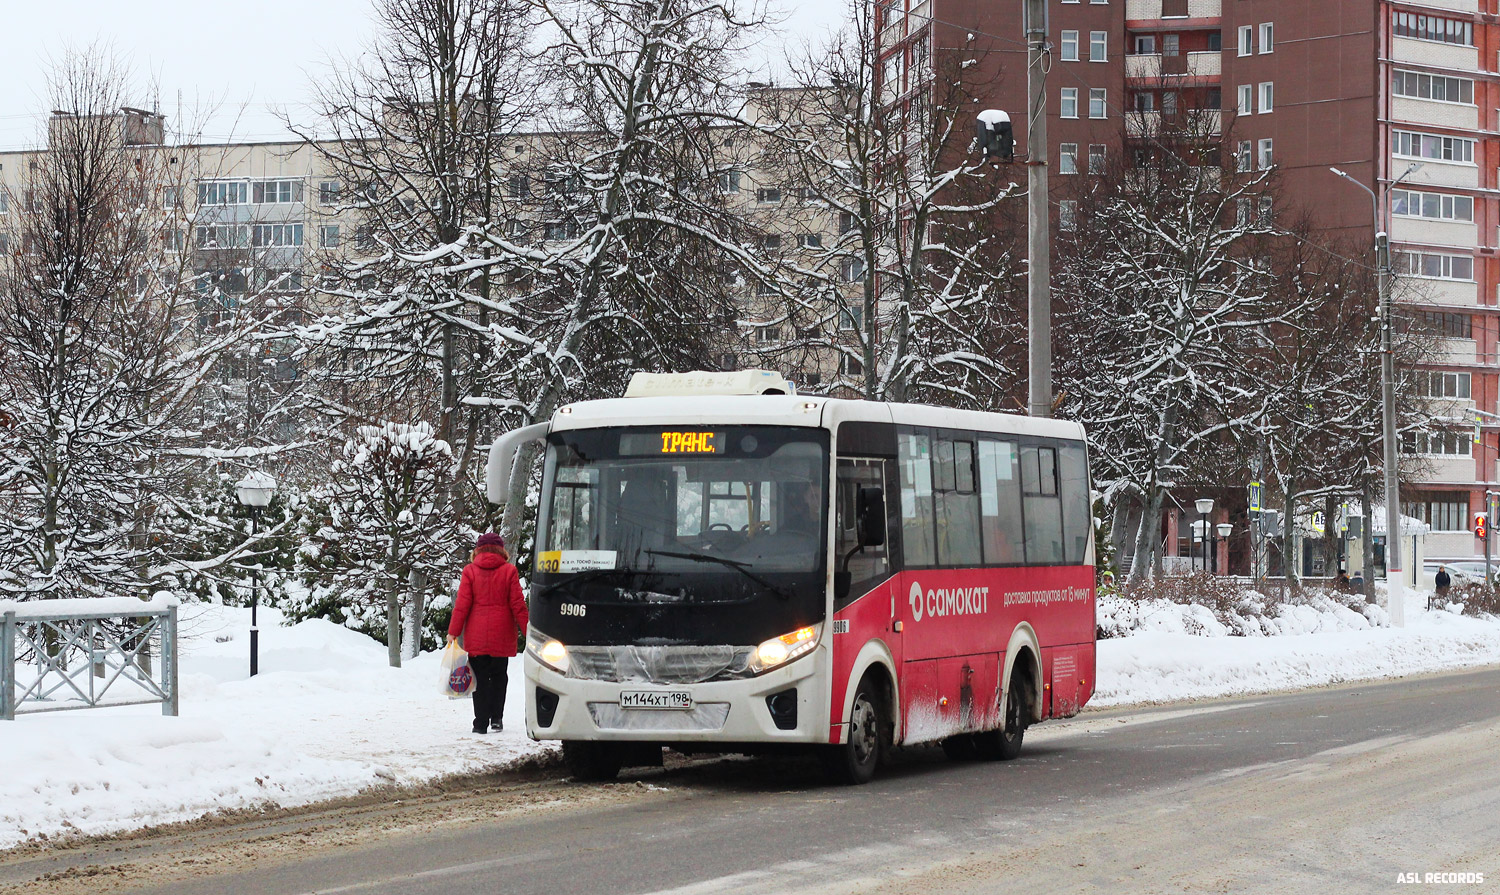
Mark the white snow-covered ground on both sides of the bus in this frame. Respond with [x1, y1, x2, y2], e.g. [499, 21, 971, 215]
[0, 595, 1500, 849]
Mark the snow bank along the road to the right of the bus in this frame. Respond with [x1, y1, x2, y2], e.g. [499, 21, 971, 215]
[1089, 592, 1500, 706]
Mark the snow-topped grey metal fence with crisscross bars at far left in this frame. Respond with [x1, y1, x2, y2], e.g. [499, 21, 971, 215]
[0, 598, 177, 721]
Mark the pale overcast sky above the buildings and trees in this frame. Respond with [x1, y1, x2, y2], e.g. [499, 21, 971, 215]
[0, 0, 845, 148]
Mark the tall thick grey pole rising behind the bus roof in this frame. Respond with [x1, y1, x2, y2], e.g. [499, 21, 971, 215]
[1025, 0, 1052, 417]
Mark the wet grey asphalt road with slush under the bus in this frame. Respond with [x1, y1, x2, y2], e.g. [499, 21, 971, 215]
[0, 669, 1500, 895]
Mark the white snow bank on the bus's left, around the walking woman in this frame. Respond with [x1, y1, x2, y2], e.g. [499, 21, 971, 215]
[0, 604, 548, 849]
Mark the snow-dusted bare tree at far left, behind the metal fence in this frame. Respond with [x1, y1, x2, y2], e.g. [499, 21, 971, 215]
[0, 49, 251, 598]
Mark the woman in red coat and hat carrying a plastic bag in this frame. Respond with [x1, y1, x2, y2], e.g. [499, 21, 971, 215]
[449, 534, 528, 733]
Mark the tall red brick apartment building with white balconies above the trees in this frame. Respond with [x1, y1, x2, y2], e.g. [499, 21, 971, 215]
[878, 0, 1500, 558]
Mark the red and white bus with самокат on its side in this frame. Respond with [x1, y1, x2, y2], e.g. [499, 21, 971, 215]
[489, 370, 1095, 783]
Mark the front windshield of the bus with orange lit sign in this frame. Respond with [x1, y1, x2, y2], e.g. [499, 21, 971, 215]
[537, 426, 828, 575]
